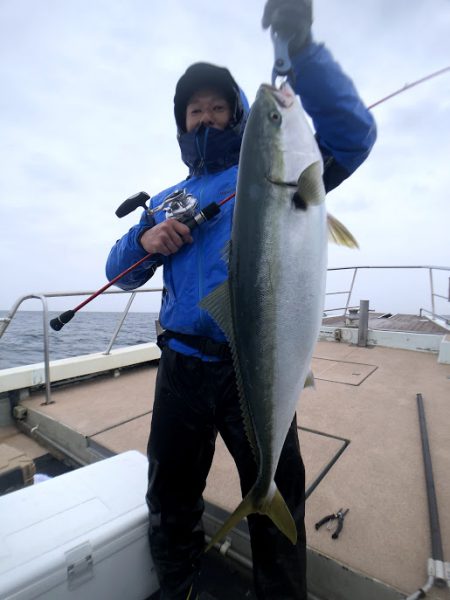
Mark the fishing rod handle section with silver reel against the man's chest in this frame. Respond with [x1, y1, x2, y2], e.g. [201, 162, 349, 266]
[50, 190, 236, 331]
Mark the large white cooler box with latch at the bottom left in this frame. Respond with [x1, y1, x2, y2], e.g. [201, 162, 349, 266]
[0, 452, 159, 600]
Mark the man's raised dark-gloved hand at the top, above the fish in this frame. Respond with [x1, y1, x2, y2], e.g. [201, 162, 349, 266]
[262, 0, 312, 56]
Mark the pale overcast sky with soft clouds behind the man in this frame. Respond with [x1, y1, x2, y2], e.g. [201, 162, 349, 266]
[0, 0, 450, 312]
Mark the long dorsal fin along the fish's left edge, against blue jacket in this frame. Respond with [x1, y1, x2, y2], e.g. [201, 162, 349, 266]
[199, 279, 259, 464]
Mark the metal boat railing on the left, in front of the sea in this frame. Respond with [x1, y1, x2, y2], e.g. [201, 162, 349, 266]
[0, 288, 162, 404]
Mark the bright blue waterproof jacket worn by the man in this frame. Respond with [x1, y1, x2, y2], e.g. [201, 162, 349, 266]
[106, 43, 376, 359]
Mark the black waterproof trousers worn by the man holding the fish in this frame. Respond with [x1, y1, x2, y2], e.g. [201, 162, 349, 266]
[147, 346, 307, 600]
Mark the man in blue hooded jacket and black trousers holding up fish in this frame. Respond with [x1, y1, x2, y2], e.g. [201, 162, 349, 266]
[107, 0, 376, 600]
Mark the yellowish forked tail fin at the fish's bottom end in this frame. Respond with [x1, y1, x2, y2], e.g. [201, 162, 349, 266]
[205, 488, 297, 552]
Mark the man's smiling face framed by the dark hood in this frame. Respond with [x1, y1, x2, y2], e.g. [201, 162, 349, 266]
[186, 89, 231, 132]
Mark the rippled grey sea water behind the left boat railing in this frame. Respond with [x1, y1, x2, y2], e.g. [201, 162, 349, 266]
[0, 311, 158, 369]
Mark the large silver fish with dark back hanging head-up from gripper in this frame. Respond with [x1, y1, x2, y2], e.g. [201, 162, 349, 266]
[201, 84, 356, 547]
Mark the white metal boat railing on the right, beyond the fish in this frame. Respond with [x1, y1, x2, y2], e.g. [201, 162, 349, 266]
[325, 265, 450, 325]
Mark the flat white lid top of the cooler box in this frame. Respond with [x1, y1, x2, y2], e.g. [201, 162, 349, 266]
[0, 451, 148, 578]
